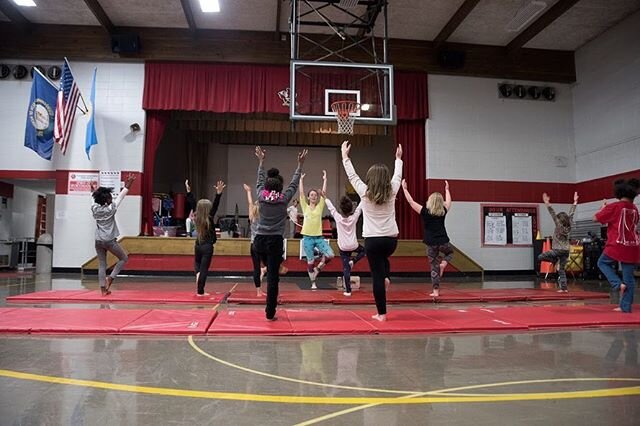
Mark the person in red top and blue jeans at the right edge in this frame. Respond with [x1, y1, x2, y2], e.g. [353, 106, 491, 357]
[594, 179, 640, 313]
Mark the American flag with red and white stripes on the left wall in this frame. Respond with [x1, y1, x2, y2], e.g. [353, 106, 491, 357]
[53, 58, 80, 154]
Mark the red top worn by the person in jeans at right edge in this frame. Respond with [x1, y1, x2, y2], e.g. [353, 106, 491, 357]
[595, 201, 640, 263]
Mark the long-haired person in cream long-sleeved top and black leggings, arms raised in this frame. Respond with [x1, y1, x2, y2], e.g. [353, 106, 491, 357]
[342, 141, 403, 321]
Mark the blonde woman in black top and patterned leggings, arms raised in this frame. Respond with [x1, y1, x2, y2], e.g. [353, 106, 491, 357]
[402, 179, 453, 297]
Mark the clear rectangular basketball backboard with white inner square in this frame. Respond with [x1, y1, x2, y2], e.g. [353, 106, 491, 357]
[287, 60, 396, 125]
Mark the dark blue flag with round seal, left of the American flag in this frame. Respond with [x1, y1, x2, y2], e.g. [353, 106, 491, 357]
[24, 68, 58, 160]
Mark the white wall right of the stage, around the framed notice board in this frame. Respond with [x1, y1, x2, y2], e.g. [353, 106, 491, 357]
[426, 75, 575, 270]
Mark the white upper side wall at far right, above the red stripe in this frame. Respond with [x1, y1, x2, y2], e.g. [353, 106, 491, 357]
[573, 12, 640, 182]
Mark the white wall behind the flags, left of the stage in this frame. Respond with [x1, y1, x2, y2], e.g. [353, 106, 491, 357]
[0, 60, 145, 268]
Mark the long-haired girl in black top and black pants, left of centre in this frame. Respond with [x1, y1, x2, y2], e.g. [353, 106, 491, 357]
[194, 180, 226, 296]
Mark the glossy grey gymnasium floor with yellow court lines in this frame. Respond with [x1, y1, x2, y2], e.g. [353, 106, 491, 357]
[0, 273, 640, 425]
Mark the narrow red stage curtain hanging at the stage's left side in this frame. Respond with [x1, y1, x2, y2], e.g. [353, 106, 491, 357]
[142, 110, 171, 235]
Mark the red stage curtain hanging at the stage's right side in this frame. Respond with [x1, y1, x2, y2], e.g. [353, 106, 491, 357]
[396, 120, 427, 239]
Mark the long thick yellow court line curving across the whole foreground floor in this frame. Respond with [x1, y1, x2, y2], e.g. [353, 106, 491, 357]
[0, 370, 640, 405]
